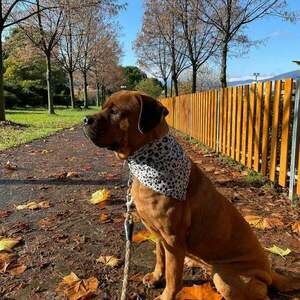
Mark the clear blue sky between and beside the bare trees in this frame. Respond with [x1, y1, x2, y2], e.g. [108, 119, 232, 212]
[118, 0, 300, 80]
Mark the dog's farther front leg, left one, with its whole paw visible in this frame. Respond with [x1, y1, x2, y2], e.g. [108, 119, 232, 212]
[143, 239, 165, 288]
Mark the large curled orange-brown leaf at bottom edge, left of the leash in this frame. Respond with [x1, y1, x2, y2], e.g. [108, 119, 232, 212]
[56, 272, 99, 300]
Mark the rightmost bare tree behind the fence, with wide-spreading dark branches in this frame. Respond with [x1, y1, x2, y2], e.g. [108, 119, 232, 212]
[195, 0, 288, 87]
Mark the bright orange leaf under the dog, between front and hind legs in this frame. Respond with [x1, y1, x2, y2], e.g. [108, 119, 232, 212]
[178, 283, 222, 300]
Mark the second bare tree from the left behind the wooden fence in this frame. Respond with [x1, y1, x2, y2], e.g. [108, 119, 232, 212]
[143, 0, 189, 95]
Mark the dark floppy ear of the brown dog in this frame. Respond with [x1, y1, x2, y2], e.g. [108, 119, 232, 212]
[138, 94, 169, 133]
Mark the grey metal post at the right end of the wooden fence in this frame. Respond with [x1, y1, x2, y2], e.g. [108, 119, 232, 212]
[289, 79, 300, 201]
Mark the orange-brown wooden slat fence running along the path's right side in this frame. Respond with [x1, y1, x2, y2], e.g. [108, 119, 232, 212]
[161, 79, 300, 198]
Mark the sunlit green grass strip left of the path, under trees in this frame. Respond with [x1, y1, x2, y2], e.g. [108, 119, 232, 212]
[0, 107, 99, 150]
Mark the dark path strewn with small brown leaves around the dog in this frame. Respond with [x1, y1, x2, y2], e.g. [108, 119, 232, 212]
[0, 128, 300, 300]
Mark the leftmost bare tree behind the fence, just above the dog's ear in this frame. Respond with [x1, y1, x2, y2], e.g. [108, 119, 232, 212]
[134, 33, 171, 97]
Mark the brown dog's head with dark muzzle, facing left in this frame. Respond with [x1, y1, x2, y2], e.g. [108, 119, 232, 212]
[84, 91, 168, 159]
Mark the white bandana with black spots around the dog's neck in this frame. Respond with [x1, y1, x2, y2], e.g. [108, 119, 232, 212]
[128, 134, 191, 200]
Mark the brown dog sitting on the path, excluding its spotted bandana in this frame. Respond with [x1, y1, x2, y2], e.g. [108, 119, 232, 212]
[85, 91, 300, 300]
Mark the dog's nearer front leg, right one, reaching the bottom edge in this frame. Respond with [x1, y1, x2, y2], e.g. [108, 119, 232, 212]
[155, 243, 185, 300]
